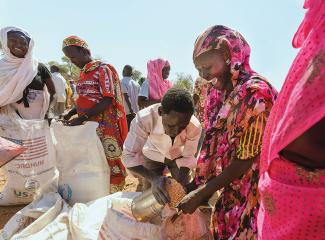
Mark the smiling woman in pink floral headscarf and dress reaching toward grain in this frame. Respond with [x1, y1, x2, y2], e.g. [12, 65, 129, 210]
[178, 25, 276, 239]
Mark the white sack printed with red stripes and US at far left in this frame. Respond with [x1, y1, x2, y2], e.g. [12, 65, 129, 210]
[0, 112, 58, 206]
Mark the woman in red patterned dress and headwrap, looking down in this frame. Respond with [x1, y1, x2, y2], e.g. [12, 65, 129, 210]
[62, 36, 128, 193]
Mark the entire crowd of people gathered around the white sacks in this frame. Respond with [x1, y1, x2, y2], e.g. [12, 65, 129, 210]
[0, 0, 325, 240]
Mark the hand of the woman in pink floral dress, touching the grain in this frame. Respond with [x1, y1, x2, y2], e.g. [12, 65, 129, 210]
[177, 188, 203, 214]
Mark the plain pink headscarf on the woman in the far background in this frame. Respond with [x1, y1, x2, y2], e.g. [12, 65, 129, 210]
[147, 58, 173, 100]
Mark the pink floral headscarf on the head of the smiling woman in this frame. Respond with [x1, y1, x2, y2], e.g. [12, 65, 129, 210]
[193, 25, 254, 87]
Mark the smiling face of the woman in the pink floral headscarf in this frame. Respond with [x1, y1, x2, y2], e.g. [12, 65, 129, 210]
[194, 50, 229, 81]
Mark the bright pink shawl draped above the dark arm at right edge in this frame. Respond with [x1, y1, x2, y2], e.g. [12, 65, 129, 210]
[261, 0, 325, 173]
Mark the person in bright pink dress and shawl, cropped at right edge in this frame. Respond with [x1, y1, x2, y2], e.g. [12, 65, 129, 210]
[258, 0, 325, 240]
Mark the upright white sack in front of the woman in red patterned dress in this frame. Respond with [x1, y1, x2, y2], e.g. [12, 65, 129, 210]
[51, 121, 110, 205]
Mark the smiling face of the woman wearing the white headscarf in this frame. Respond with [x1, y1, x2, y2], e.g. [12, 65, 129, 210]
[7, 32, 30, 58]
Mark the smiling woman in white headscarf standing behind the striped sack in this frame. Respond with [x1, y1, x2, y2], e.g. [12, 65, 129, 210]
[0, 27, 55, 119]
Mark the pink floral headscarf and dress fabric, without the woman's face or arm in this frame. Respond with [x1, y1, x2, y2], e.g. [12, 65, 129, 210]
[193, 26, 277, 239]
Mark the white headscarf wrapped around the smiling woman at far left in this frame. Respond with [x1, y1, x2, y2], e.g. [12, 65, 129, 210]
[0, 27, 38, 107]
